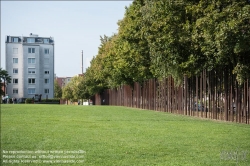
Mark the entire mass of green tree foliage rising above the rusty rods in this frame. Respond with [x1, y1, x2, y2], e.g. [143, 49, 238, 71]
[84, 0, 250, 91]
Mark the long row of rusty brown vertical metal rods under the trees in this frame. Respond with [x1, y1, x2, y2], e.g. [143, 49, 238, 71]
[92, 71, 250, 124]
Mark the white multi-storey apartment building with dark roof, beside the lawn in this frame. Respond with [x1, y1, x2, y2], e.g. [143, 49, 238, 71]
[5, 33, 54, 99]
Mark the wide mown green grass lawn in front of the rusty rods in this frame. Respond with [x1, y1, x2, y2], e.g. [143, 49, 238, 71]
[1, 104, 250, 166]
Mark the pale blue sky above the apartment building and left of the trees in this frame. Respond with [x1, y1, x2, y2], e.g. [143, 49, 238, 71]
[1, 1, 132, 77]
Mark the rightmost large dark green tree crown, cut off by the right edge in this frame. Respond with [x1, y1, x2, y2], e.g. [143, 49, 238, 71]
[191, 0, 250, 84]
